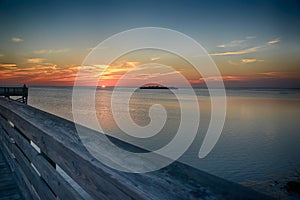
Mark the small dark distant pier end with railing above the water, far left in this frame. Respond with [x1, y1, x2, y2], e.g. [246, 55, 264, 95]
[0, 84, 28, 104]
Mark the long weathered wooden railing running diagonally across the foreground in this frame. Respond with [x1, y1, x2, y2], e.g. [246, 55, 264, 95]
[0, 98, 267, 200]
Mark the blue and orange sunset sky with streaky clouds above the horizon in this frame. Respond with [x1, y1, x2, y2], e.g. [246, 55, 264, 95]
[0, 0, 300, 88]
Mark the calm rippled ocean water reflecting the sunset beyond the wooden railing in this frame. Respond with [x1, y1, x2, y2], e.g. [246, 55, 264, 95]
[29, 87, 300, 185]
